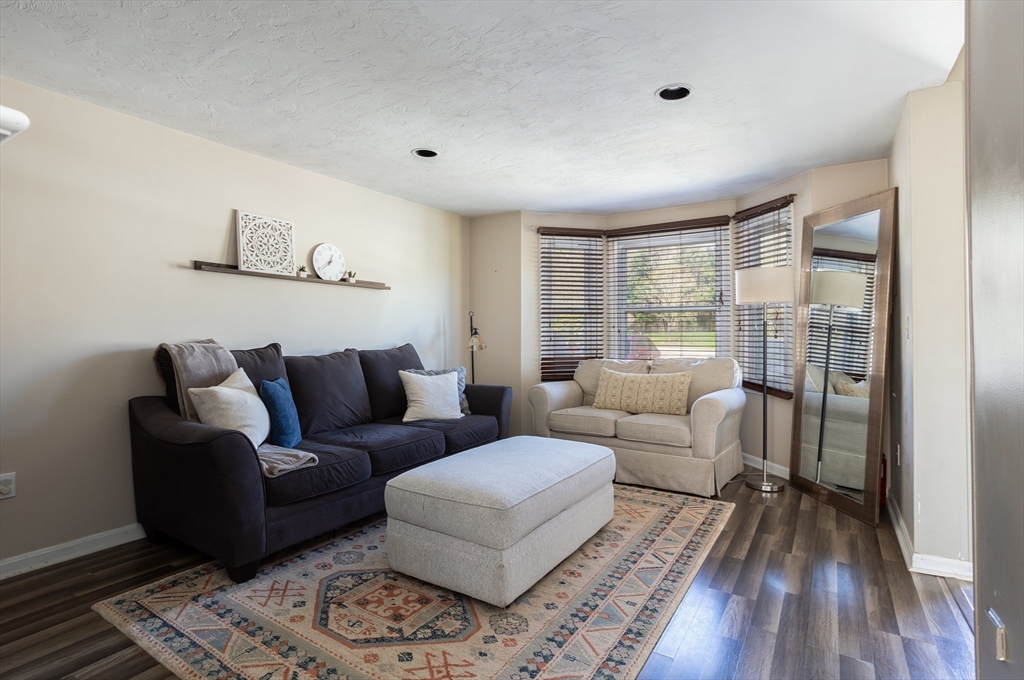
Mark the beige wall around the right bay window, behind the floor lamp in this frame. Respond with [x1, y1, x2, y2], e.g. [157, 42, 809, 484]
[736, 159, 889, 468]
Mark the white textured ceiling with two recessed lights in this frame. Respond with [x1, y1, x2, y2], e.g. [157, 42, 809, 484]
[0, 0, 964, 215]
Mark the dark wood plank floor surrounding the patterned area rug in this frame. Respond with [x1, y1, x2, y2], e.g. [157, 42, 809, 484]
[0, 473, 974, 680]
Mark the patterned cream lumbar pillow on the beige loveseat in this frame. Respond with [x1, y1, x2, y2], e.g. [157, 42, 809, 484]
[594, 369, 692, 416]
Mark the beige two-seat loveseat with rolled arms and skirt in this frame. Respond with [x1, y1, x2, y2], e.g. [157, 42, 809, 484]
[528, 357, 746, 496]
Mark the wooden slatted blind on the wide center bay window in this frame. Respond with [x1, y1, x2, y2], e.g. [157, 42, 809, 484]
[605, 222, 732, 358]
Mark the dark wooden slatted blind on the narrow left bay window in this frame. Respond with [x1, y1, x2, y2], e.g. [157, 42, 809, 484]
[538, 227, 604, 381]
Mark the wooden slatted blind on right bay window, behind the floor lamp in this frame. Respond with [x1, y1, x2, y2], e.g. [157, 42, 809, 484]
[733, 195, 796, 398]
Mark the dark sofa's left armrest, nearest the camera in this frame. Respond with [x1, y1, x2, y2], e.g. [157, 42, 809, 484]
[128, 396, 267, 567]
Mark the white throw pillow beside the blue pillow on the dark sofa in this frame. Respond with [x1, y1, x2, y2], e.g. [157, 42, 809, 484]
[188, 369, 270, 447]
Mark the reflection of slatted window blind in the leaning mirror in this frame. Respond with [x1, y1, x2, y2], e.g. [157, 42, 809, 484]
[807, 249, 874, 381]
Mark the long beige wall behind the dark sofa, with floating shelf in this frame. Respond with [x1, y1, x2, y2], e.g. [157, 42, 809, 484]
[0, 78, 468, 558]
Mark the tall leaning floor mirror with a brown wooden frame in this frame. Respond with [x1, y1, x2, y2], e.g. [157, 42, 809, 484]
[790, 189, 896, 525]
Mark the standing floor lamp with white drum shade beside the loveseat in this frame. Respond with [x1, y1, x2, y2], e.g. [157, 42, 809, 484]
[736, 267, 794, 492]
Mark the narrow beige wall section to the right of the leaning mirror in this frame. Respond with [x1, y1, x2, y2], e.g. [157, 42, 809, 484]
[890, 71, 972, 570]
